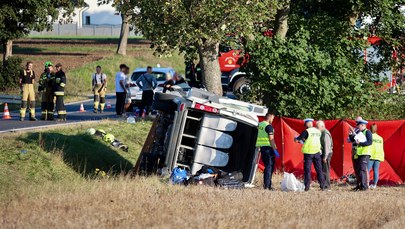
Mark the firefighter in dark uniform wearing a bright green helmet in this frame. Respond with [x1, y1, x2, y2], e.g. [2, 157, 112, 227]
[38, 61, 55, 121]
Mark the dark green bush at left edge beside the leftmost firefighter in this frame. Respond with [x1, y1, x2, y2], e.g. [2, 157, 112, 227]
[0, 56, 22, 91]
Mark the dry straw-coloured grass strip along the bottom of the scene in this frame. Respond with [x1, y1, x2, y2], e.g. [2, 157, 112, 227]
[0, 174, 405, 228]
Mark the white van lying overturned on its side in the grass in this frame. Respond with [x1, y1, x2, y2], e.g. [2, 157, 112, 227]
[134, 88, 267, 184]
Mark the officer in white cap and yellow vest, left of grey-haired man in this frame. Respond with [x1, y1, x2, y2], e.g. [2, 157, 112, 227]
[294, 118, 325, 191]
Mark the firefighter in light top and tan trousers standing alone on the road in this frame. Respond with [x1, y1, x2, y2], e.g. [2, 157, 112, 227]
[92, 66, 107, 113]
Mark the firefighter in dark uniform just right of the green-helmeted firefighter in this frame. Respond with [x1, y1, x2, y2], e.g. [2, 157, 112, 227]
[54, 63, 66, 121]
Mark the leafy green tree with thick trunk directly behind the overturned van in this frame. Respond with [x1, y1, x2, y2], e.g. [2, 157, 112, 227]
[130, 0, 277, 94]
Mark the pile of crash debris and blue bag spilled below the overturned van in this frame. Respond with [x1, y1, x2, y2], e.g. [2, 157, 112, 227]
[170, 166, 244, 189]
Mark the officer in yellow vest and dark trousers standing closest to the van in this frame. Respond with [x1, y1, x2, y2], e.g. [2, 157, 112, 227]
[256, 112, 279, 190]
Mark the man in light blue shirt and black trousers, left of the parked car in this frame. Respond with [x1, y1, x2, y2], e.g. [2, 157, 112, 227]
[115, 64, 129, 117]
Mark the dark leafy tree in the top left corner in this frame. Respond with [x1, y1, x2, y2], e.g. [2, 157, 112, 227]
[0, 0, 83, 63]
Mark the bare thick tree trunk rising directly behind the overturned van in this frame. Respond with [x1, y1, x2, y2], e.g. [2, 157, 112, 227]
[198, 40, 222, 96]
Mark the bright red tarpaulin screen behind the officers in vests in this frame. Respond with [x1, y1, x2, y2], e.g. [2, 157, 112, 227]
[259, 117, 405, 185]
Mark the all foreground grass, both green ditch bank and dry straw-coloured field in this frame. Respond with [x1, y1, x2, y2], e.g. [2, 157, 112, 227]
[0, 121, 405, 229]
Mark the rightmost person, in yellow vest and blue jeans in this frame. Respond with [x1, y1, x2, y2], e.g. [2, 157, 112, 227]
[368, 124, 384, 189]
